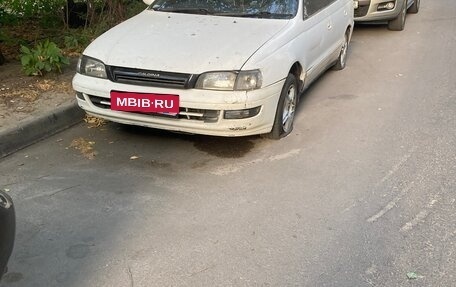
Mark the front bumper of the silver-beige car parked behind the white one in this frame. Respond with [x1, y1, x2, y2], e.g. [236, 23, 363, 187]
[355, 0, 403, 22]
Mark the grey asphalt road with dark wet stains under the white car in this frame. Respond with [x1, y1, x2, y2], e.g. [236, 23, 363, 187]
[0, 0, 456, 287]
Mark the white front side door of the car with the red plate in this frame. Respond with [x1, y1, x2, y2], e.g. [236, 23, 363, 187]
[302, 0, 330, 86]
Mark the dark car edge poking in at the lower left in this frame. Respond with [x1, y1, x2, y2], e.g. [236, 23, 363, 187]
[0, 191, 16, 279]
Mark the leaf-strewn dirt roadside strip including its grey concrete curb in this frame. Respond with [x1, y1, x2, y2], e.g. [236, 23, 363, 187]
[0, 63, 84, 158]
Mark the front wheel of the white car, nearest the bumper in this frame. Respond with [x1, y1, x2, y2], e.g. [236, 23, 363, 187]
[266, 74, 299, 140]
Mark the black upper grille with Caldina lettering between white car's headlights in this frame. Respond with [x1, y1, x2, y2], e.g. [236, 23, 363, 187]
[107, 66, 197, 89]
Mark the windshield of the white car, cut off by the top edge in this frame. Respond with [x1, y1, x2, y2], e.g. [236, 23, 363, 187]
[149, 0, 299, 19]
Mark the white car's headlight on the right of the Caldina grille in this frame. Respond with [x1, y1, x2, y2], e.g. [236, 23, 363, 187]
[195, 70, 262, 91]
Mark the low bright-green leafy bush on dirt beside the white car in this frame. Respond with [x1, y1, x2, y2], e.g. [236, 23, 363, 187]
[21, 40, 70, 76]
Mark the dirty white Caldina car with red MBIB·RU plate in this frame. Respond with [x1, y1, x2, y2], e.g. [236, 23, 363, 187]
[73, 0, 354, 139]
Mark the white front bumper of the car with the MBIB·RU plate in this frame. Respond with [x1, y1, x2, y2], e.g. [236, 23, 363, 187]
[73, 74, 284, 136]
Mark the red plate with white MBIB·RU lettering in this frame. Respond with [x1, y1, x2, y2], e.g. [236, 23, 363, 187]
[111, 91, 179, 115]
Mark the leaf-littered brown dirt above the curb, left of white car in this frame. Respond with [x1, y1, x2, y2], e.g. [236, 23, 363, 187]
[0, 58, 77, 129]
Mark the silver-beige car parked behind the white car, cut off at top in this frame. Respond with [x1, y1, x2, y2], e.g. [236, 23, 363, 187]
[355, 0, 420, 31]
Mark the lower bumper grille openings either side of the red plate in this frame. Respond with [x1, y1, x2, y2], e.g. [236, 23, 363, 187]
[89, 95, 220, 123]
